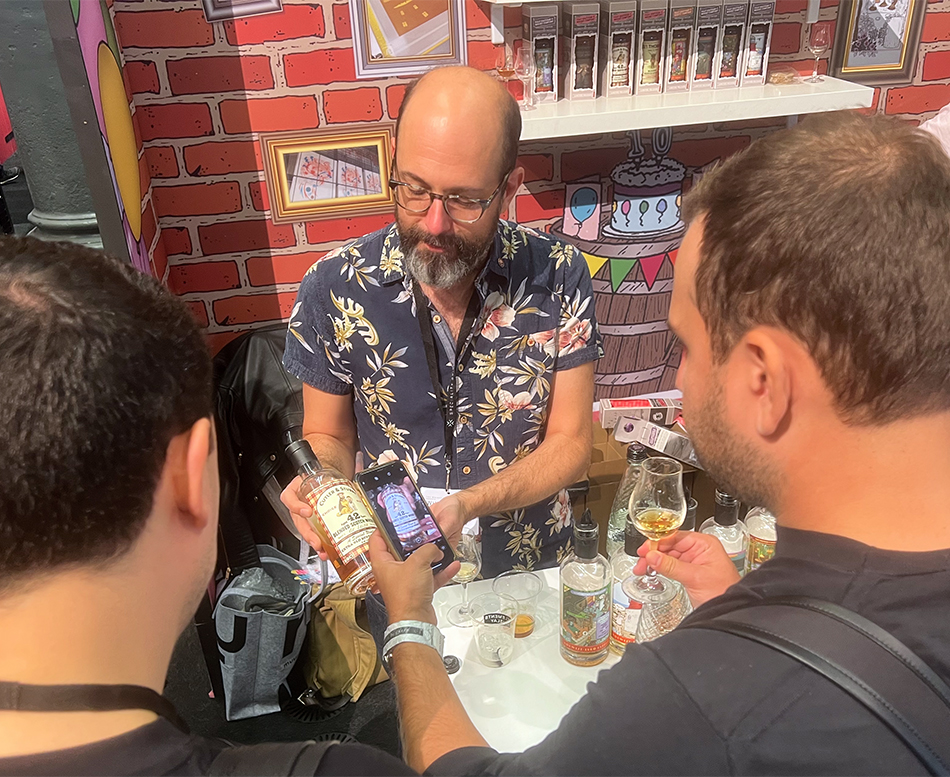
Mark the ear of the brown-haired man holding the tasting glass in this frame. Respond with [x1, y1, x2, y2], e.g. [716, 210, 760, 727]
[738, 328, 792, 437]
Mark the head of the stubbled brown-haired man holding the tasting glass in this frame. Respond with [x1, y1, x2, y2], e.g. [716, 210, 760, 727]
[670, 114, 950, 504]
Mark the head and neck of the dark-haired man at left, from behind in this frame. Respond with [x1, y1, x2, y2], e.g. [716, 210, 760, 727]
[0, 237, 218, 720]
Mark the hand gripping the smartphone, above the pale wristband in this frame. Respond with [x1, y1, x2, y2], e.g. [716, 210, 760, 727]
[369, 531, 459, 625]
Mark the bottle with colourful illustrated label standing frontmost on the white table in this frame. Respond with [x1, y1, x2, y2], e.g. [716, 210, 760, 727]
[560, 510, 610, 666]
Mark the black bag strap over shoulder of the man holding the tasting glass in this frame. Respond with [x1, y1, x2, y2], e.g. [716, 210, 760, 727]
[683, 596, 950, 775]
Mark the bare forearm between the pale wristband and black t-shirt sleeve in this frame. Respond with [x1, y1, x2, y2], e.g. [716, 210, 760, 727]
[393, 642, 488, 772]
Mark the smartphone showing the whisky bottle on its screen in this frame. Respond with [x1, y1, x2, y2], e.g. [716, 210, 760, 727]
[356, 461, 455, 572]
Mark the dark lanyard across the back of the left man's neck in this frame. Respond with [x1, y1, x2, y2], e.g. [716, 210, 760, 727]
[0, 681, 188, 734]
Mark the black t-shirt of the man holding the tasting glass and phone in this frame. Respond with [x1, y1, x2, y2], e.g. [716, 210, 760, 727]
[428, 528, 950, 775]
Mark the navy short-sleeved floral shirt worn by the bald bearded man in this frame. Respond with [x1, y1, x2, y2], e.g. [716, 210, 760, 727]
[284, 221, 602, 577]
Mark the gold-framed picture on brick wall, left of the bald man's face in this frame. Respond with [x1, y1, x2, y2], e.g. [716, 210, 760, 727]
[261, 124, 394, 224]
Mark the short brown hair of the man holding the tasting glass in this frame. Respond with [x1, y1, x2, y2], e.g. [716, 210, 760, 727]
[684, 113, 950, 424]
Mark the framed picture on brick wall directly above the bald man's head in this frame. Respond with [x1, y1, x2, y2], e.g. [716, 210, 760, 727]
[350, 0, 468, 78]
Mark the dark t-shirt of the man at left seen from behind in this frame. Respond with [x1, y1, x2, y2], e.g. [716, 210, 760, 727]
[0, 719, 415, 777]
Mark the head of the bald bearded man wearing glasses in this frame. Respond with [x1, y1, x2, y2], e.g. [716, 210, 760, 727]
[393, 67, 524, 288]
